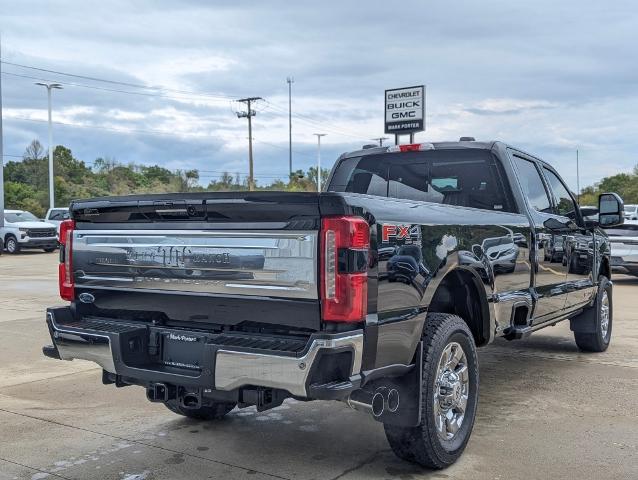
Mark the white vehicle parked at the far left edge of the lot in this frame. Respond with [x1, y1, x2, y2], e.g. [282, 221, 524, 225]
[0, 210, 58, 253]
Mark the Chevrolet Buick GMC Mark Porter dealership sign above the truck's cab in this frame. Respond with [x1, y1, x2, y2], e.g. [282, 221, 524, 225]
[385, 85, 425, 135]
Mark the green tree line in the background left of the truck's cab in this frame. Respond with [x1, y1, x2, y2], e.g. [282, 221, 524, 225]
[4, 140, 329, 217]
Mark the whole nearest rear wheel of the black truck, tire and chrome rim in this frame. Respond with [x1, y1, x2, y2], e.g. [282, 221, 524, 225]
[384, 313, 479, 469]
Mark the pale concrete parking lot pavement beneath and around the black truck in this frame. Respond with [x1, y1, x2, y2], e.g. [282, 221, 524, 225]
[0, 252, 638, 480]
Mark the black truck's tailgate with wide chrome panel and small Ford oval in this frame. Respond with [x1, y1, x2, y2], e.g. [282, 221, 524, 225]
[71, 192, 336, 330]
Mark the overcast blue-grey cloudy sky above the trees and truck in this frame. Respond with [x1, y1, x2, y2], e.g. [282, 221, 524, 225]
[0, 0, 638, 189]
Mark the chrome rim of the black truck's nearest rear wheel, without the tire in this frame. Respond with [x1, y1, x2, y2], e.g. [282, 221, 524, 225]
[433, 342, 470, 440]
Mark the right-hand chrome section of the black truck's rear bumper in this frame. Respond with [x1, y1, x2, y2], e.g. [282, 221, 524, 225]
[215, 333, 363, 397]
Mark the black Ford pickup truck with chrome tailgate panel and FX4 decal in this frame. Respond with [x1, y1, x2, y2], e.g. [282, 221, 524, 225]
[44, 141, 623, 468]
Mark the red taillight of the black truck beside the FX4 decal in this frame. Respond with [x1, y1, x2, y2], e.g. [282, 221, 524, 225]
[321, 216, 370, 322]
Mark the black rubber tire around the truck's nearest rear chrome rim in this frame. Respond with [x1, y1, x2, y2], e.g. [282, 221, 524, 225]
[384, 313, 479, 469]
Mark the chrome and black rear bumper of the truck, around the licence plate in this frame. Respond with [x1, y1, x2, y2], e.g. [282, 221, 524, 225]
[45, 308, 363, 397]
